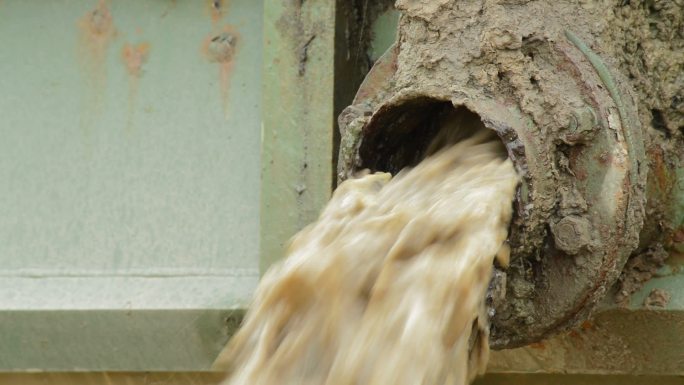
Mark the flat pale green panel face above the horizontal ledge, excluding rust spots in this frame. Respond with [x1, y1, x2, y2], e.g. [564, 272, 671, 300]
[0, 1, 261, 275]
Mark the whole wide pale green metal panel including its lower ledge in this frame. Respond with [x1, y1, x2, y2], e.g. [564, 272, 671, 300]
[0, 0, 263, 371]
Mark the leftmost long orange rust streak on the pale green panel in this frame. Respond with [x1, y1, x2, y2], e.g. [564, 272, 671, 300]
[77, 0, 116, 134]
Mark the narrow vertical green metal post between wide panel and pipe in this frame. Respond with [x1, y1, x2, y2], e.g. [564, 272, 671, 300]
[261, 0, 335, 271]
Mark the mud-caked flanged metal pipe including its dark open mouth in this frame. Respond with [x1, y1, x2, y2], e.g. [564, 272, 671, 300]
[338, 0, 684, 348]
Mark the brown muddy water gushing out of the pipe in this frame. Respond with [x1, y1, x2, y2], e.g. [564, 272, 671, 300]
[223, 133, 517, 385]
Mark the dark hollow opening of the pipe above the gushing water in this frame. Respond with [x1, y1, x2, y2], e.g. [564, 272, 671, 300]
[359, 97, 507, 175]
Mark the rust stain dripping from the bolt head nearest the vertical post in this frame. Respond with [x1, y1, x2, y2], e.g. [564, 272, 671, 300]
[202, 26, 240, 117]
